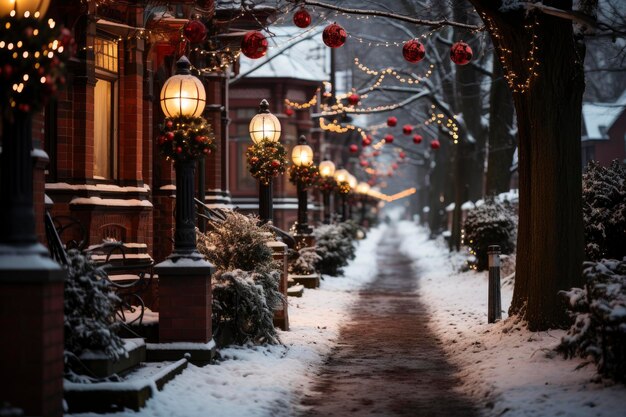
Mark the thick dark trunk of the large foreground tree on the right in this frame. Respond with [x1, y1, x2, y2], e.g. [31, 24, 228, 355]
[472, 0, 584, 330]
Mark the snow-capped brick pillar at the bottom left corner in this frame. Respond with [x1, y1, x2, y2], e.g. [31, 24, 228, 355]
[0, 262, 65, 416]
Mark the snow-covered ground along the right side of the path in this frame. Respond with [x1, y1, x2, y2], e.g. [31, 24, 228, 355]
[398, 222, 626, 417]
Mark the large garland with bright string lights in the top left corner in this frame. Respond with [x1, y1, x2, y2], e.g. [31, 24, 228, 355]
[0, 10, 75, 112]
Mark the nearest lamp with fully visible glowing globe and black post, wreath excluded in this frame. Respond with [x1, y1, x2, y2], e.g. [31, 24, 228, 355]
[160, 56, 206, 260]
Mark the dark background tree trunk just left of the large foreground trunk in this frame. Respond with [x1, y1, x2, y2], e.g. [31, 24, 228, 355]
[486, 56, 516, 195]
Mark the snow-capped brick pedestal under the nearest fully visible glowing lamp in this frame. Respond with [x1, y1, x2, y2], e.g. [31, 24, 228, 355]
[154, 258, 215, 343]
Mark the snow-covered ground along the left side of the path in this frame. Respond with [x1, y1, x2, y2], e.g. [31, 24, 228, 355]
[74, 226, 386, 417]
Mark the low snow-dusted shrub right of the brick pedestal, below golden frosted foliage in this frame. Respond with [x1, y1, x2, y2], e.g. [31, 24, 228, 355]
[212, 269, 282, 344]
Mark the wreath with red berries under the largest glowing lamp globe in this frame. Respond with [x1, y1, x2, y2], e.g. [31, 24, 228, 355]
[157, 116, 216, 161]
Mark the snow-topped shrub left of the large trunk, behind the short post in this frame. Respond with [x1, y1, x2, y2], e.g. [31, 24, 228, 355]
[463, 198, 517, 271]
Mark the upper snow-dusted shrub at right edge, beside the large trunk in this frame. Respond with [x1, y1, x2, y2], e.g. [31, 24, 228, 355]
[583, 161, 626, 261]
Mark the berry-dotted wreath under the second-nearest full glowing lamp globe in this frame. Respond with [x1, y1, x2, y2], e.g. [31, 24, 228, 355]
[246, 140, 287, 185]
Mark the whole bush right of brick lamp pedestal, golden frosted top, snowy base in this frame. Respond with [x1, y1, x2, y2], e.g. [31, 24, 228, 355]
[197, 211, 283, 344]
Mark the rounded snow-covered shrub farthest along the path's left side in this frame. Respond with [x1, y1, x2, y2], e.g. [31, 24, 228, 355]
[313, 223, 356, 276]
